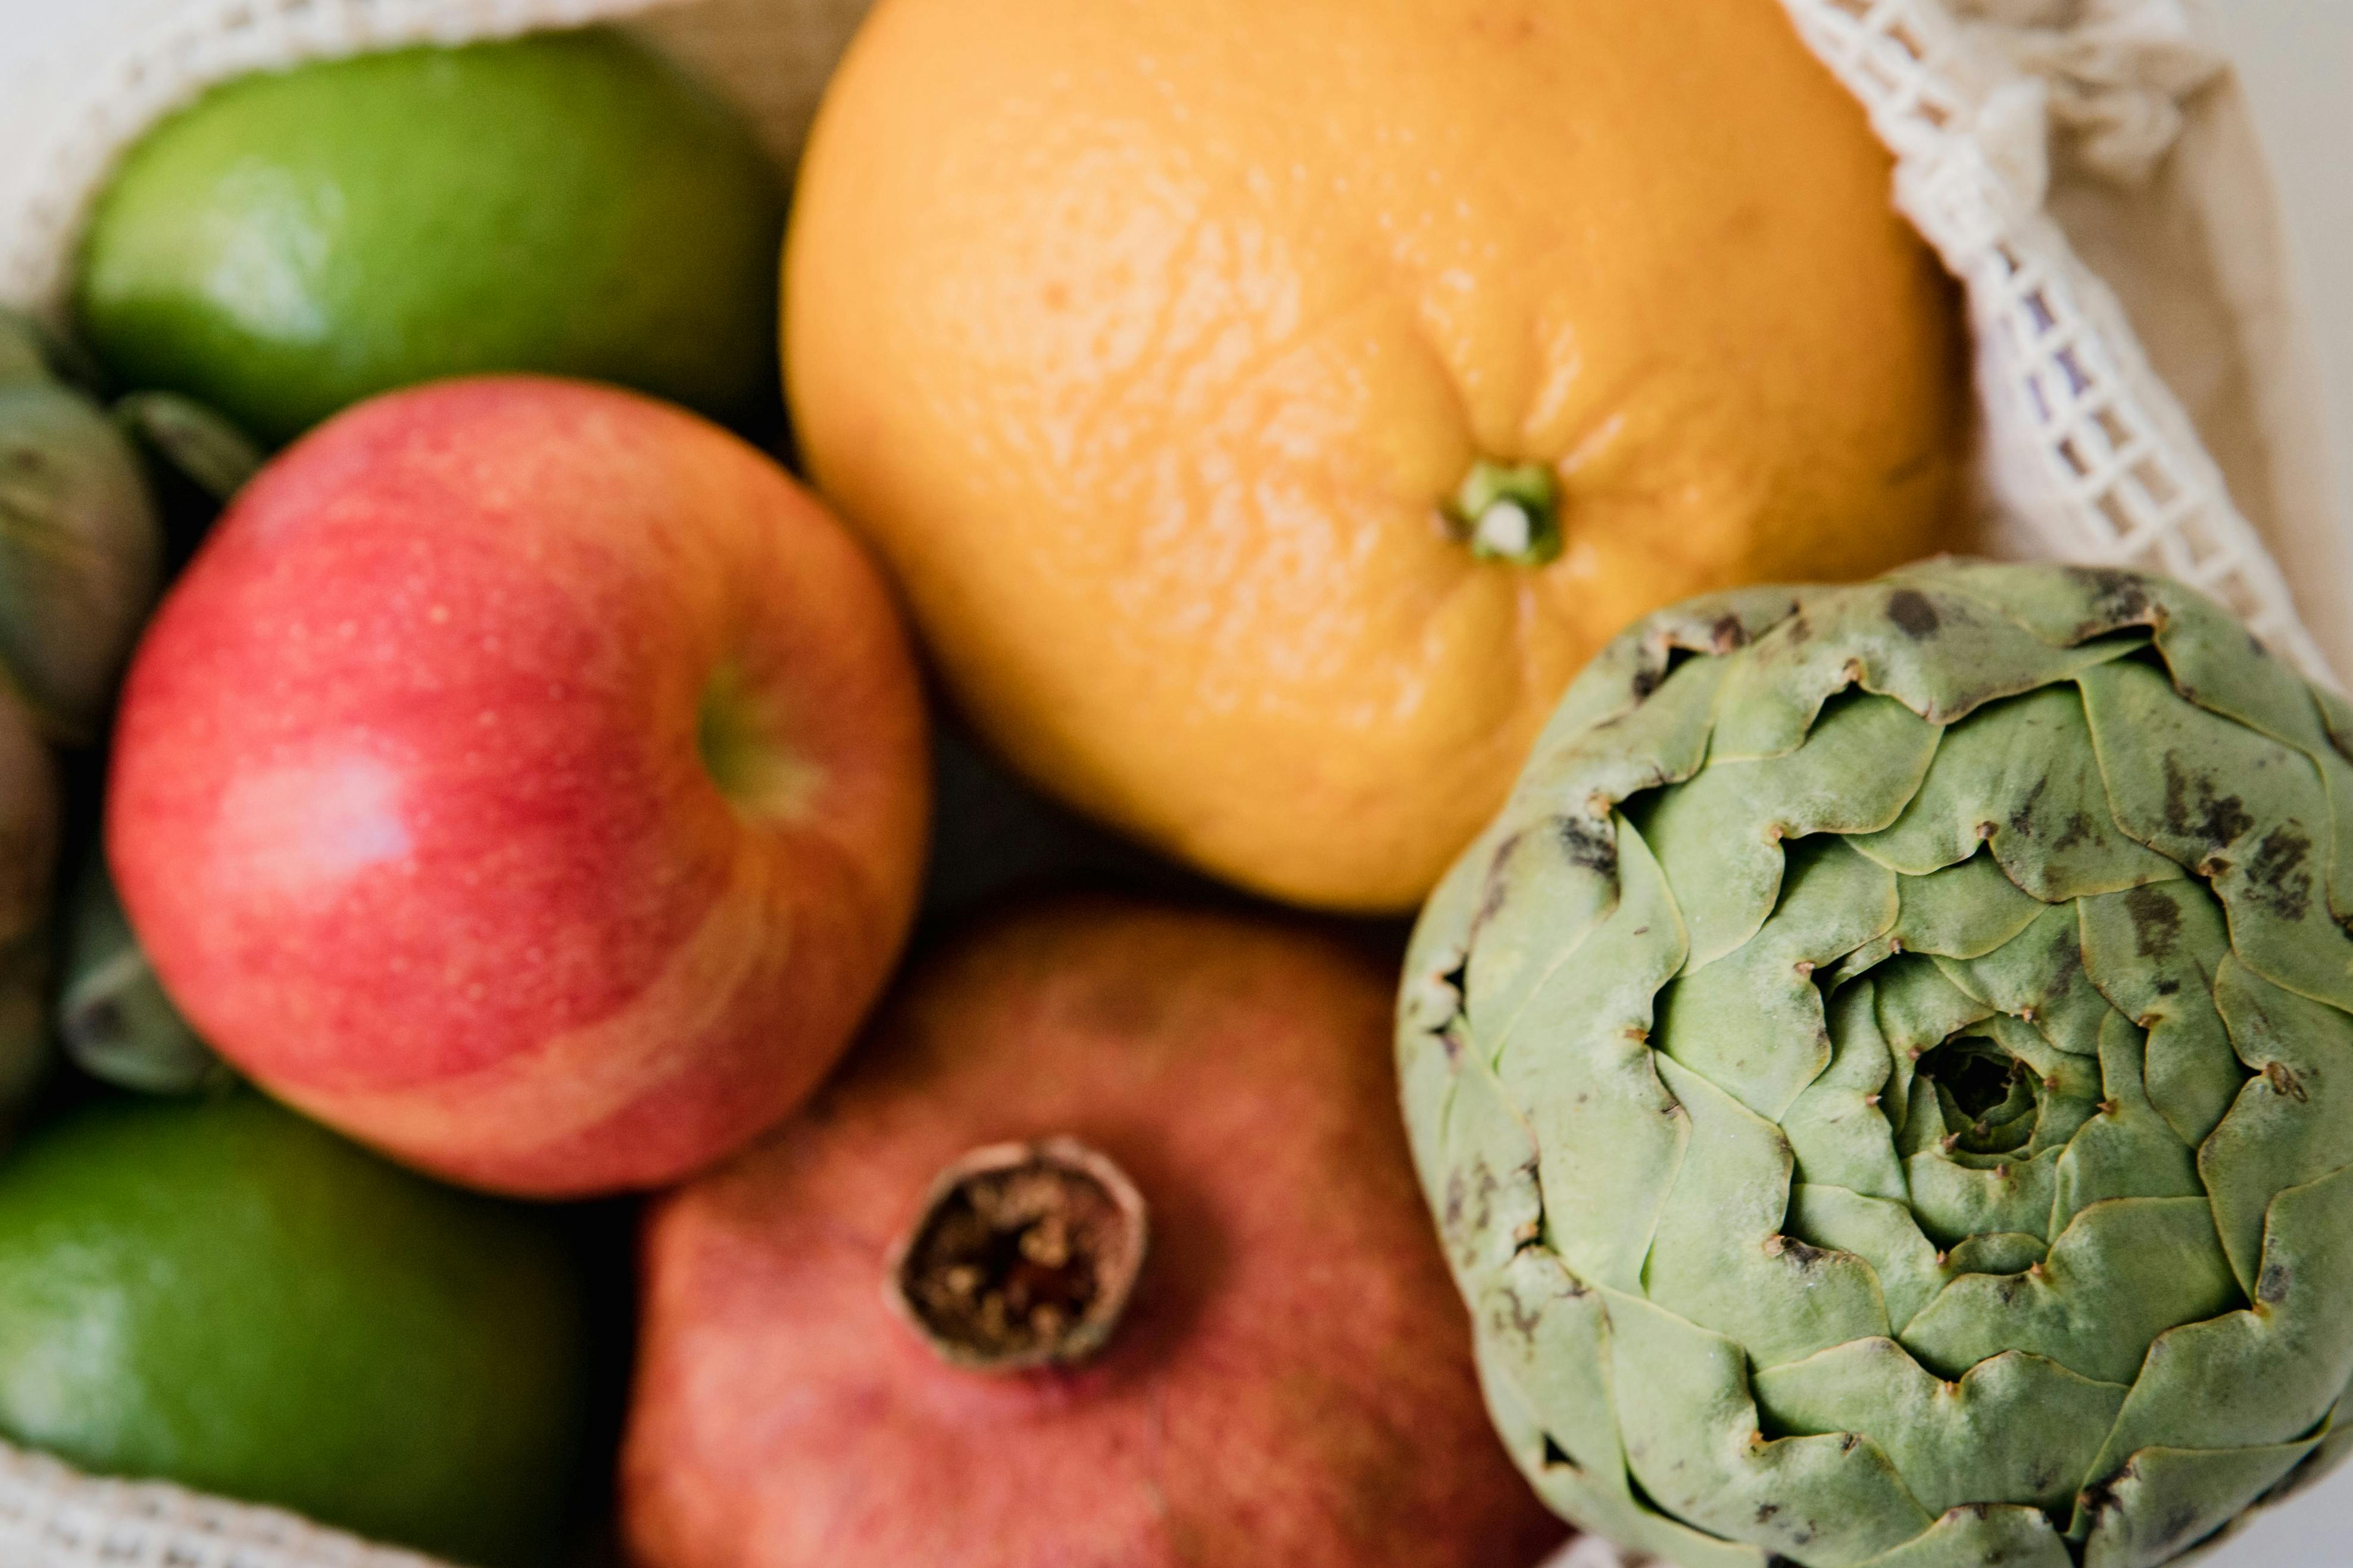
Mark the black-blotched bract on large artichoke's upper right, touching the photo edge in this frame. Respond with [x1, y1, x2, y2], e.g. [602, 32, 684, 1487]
[2083, 664, 2353, 1010]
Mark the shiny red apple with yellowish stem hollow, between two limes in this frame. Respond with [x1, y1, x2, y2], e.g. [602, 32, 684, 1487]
[106, 377, 929, 1196]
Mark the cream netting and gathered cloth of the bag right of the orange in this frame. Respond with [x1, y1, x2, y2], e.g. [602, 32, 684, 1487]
[1784, 0, 2327, 678]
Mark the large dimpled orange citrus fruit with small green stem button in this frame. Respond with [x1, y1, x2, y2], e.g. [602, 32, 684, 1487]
[786, 0, 1965, 911]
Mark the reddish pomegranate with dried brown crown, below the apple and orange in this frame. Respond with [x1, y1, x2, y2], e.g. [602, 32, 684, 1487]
[621, 899, 1565, 1568]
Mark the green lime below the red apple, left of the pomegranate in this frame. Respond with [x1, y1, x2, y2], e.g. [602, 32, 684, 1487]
[0, 1090, 583, 1568]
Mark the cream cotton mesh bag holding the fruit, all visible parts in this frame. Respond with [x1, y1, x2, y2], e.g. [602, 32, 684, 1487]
[0, 0, 2353, 1568]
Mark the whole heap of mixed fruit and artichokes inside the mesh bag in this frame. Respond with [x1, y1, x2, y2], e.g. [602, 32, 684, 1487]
[0, 0, 2353, 1568]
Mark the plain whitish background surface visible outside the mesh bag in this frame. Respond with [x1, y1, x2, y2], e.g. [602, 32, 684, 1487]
[0, 0, 2353, 1568]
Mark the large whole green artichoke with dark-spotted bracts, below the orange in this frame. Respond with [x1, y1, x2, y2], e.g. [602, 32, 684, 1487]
[1397, 560, 2353, 1568]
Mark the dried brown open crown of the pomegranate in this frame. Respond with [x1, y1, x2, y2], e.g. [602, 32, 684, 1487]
[887, 1137, 1149, 1373]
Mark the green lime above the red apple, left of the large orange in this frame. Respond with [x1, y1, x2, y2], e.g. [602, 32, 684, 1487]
[77, 30, 784, 445]
